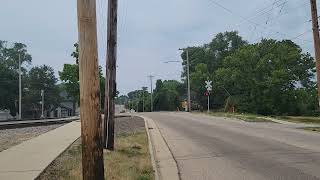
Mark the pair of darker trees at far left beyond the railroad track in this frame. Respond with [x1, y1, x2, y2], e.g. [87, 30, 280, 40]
[0, 41, 62, 118]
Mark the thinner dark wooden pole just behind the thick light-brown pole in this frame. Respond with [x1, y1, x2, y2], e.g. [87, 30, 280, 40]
[104, 0, 118, 150]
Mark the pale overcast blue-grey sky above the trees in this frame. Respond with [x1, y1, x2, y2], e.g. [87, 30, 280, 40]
[0, 0, 313, 94]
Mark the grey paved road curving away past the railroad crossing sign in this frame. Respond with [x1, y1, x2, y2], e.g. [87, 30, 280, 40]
[144, 112, 320, 180]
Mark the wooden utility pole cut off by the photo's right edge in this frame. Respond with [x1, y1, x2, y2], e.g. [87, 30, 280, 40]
[310, 0, 320, 107]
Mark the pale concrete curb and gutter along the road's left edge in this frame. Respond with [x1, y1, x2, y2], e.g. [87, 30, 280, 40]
[135, 114, 180, 180]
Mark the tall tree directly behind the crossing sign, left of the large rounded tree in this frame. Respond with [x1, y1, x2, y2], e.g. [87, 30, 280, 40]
[181, 31, 248, 108]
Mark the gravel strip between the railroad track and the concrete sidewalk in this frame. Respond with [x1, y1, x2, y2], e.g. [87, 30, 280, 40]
[0, 124, 63, 152]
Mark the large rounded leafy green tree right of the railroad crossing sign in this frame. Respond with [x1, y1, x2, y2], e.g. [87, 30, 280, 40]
[215, 40, 315, 115]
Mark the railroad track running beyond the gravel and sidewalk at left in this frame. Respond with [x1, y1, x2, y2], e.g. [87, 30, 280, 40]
[0, 117, 80, 129]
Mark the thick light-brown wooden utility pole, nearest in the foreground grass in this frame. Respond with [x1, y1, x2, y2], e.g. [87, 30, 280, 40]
[77, 0, 104, 180]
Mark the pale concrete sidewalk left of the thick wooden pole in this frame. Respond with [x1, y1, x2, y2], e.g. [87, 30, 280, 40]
[0, 121, 81, 180]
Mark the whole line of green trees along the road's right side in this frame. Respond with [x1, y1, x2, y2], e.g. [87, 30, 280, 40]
[122, 31, 318, 115]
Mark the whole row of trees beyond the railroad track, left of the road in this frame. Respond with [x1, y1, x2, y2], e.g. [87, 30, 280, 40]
[0, 40, 105, 118]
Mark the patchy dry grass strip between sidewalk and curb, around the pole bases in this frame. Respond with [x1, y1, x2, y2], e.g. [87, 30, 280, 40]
[37, 131, 154, 180]
